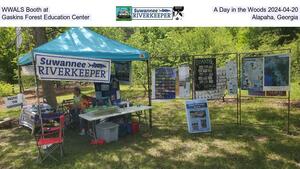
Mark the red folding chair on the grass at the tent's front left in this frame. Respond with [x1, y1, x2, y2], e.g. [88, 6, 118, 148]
[36, 115, 65, 162]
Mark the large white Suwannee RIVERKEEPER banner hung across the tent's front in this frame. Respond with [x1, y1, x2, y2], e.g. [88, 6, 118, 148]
[34, 53, 111, 83]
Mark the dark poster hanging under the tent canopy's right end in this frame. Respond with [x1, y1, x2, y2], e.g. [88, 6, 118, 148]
[114, 62, 132, 84]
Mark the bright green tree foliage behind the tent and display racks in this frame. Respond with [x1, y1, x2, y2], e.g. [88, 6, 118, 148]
[0, 27, 300, 84]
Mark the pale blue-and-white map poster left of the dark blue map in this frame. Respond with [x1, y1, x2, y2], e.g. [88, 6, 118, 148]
[242, 57, 264, 91]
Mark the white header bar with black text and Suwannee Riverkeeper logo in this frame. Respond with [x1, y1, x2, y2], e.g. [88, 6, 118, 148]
[0, 0, 300, 27]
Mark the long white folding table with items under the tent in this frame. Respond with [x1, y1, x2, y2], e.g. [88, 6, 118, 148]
[79, 105, 152, 139]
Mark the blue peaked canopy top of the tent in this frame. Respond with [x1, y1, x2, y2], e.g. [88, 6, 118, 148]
[18, 28, 149, 66]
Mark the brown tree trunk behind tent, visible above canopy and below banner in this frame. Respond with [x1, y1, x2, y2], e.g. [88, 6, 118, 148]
[33, 27, 57, 108]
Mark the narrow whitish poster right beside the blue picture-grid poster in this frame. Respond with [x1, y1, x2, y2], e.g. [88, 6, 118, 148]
[178, 65, 190, 98]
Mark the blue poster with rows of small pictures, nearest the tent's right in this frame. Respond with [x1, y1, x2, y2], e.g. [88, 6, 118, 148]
[155, 67, 176, 99]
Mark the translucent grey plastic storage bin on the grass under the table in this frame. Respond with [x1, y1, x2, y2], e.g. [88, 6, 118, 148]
[96, 122, 119, 143]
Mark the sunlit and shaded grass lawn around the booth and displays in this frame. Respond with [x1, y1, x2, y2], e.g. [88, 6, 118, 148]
[0, 88, 300, 169]
